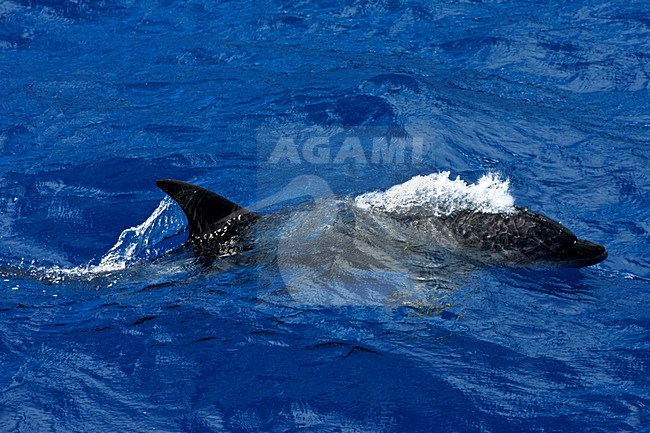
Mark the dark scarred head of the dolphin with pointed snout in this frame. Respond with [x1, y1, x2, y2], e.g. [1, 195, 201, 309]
[451, 208, 607, 268]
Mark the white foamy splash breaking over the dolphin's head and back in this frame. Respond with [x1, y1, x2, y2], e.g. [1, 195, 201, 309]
[355, 171, 515, 216]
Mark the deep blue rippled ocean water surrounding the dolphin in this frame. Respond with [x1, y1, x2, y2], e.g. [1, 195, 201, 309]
[0, 0, 650, 432]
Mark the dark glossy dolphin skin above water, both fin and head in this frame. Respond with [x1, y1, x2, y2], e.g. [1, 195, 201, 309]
[156, 179, 607, 268]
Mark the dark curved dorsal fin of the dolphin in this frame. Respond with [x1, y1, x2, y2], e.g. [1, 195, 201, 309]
[156, 179, 257, 238]
